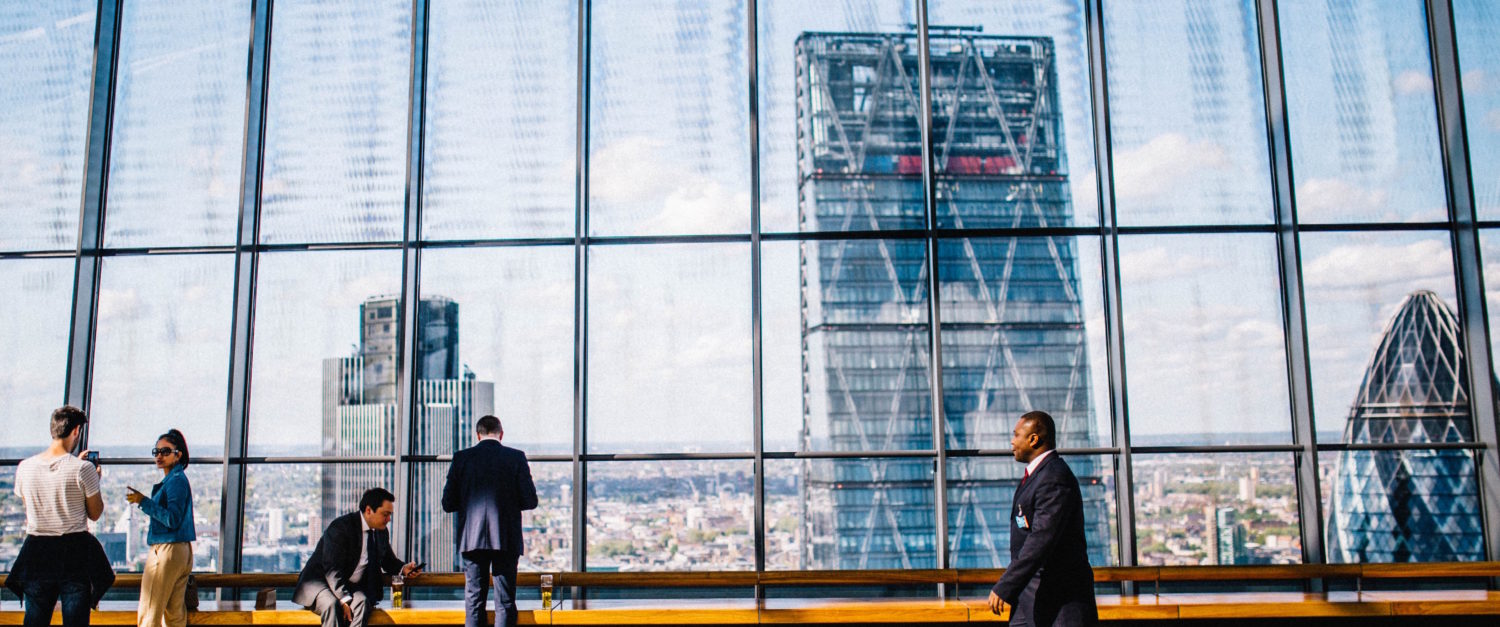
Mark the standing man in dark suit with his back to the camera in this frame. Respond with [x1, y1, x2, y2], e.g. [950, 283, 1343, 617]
[443, 416, 537, 627]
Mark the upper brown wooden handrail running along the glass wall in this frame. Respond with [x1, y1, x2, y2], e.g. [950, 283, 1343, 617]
[0, 561, 1500, 588]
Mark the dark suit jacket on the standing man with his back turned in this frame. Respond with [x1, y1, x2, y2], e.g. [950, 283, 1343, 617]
[443, 440, 537, 555]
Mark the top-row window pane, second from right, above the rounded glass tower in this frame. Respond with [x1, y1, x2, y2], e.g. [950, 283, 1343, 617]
[1277, 0, 1448, 224]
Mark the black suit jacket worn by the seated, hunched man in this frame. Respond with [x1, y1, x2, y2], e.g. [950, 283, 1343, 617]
[291, 512, 407, 606]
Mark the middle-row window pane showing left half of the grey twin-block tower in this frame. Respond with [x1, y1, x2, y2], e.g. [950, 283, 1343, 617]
[249, 251, 401, 456]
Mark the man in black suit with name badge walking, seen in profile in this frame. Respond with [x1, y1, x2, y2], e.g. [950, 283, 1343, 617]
[990, 411, 1100, 627]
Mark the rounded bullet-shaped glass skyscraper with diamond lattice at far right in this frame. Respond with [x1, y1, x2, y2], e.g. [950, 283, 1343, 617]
[1328, 291, 1484, 563]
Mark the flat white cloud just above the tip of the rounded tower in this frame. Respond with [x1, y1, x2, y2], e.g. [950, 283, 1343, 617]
[1302, 240, 1454, 291]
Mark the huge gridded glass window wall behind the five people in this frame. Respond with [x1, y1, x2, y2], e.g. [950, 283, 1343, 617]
[0, 0, 1500, 572]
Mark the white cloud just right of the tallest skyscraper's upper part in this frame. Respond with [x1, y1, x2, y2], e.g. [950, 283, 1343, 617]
[1115, 134, 1230, 200]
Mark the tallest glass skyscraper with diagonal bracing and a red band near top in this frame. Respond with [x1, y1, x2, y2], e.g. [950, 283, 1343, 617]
[797, 29, 1109, 569]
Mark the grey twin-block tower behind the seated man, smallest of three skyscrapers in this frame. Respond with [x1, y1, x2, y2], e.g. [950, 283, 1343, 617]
[323, 296, 495, 572]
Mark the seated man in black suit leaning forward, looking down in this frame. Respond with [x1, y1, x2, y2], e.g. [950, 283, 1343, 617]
[291, 488, 422, 627]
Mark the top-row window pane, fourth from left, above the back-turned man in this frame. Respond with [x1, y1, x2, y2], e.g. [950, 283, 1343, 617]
[422, 0, 578, 240]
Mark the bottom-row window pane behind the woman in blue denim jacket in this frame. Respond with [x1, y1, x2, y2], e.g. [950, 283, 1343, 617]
[90, 462, 224, 573]
